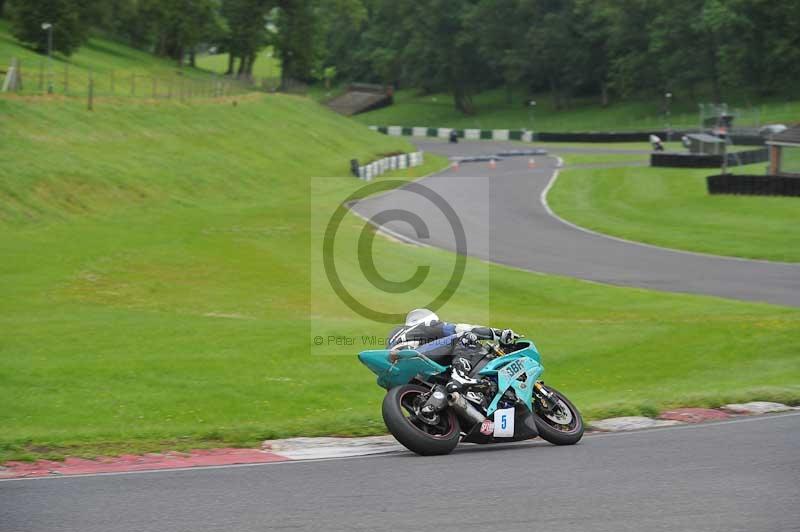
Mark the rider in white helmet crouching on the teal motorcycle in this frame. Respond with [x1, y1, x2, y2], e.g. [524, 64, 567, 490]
[387, 308, 519, 414]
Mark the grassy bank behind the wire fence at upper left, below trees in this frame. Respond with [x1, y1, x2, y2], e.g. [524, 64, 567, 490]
[0, 19, 236, 98]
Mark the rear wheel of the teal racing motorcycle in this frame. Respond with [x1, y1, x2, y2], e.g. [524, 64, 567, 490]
[381, 384, 461, 456]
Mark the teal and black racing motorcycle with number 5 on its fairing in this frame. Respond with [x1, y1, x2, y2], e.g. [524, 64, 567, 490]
[358, 338, 584, 456]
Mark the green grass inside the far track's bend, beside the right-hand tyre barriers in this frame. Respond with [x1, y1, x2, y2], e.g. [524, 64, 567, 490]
[548, 162, 800, 262]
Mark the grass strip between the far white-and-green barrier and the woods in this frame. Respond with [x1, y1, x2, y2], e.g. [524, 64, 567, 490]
[355, 89, 800, 131]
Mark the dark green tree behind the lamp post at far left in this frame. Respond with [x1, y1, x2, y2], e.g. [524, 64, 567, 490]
[8, 0, 93, 55]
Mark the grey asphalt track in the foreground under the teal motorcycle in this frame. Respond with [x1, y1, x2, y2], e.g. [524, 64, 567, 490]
[0, 412, 800, 532]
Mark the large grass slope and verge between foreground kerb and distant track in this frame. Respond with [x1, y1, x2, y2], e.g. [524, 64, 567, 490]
[0, 90, 800, 461]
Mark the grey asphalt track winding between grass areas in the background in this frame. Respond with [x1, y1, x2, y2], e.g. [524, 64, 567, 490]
[353, 141, 800, 307]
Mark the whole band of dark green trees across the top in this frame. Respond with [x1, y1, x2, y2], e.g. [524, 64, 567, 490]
[0, 0, 800, 113]
